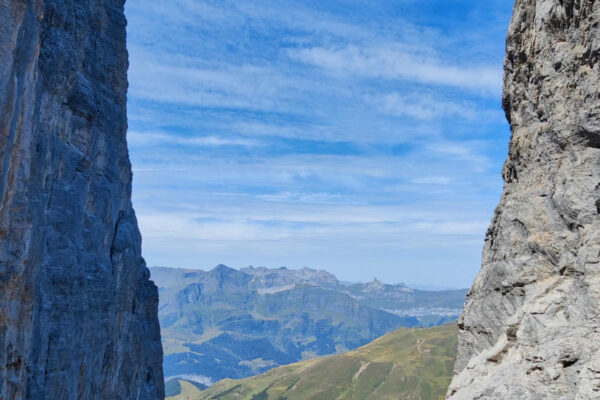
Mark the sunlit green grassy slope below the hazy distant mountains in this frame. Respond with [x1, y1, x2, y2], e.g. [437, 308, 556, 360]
[173, 324, 458, 400]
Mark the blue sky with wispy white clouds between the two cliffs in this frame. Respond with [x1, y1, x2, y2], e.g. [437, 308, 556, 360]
[126, 0, 512, 287]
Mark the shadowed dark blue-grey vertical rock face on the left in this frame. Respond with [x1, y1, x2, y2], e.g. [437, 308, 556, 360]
[0, 0, 164, 400]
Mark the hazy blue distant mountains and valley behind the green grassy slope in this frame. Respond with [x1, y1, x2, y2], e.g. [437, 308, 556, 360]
[150, 265, 467, 386]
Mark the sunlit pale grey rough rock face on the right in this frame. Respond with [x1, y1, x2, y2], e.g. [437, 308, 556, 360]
[448, 0, 600, 399]
